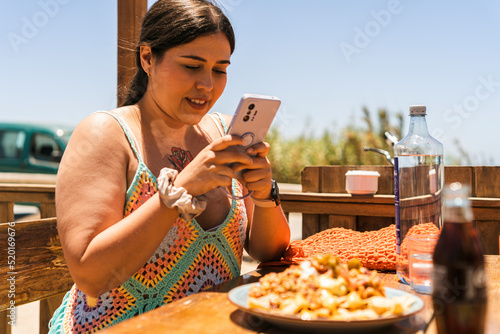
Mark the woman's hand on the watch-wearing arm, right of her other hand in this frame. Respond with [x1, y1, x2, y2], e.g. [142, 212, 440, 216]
[234, 142, 272, 199]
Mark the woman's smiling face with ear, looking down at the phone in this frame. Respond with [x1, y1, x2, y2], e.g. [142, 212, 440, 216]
[141, 33, 231, 125]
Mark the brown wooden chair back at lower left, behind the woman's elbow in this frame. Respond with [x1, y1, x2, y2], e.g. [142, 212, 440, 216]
[0, 218, 73, 334]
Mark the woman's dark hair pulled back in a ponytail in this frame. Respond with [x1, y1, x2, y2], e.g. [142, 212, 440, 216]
[122, 0, 235, 106]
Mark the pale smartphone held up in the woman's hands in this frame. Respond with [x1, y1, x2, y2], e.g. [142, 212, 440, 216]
[227, 94, 281, 148]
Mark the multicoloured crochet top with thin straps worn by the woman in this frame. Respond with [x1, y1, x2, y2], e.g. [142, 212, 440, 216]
[49, 114, 247, 333]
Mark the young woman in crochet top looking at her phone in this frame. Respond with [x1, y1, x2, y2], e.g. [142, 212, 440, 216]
[50, 0, 290, 333]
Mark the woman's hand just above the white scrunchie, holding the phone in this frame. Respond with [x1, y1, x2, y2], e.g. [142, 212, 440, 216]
[174, 135, 253, 196]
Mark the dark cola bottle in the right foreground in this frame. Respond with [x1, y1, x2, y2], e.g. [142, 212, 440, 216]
[432, 183, 487, 334]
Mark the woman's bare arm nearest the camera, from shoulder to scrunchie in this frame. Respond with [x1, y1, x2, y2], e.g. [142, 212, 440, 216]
[56, 114, 178, 296]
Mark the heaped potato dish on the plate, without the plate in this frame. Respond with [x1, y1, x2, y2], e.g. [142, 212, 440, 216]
[248, 255, 414, 321]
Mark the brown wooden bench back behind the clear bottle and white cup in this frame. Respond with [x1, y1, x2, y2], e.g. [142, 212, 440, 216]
[281, 166, 500, 255]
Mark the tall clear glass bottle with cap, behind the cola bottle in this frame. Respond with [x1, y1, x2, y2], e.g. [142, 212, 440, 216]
[394, 105, 444, 284]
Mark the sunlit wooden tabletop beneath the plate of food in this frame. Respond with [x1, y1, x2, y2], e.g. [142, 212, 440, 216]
[105, 255, 500, 334]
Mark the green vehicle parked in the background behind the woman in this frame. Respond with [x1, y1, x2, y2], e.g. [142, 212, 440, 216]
[0, 123, 73, 174]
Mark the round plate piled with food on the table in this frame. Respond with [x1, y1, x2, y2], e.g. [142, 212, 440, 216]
[228, 255, 424, 331]
